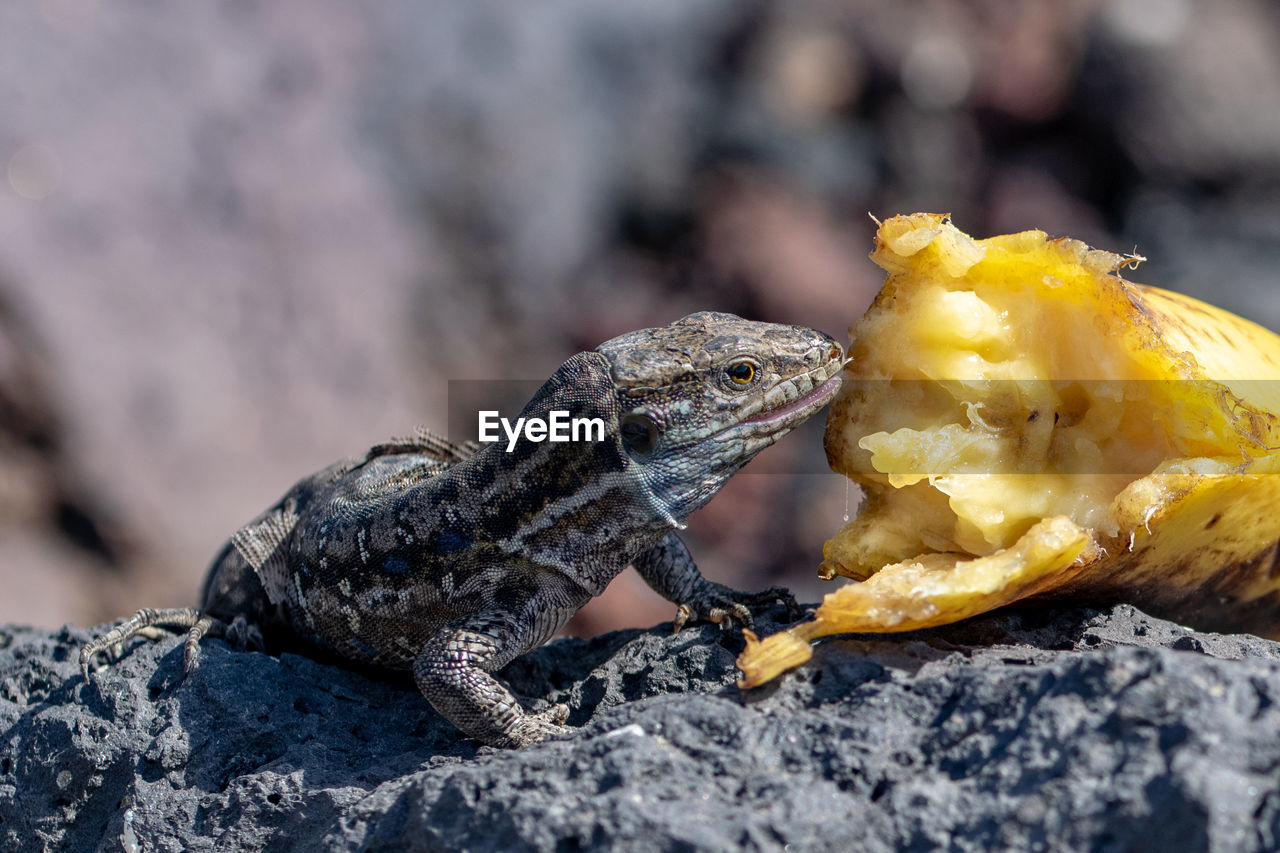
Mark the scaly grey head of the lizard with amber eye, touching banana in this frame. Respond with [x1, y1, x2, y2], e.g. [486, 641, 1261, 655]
[596, 311, 844, 521]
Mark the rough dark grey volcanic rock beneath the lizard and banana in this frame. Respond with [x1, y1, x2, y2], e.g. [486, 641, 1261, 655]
[0, 606, 1280, 850]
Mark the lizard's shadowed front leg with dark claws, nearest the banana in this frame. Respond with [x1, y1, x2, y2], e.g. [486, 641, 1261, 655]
[634, 533, 799, 631]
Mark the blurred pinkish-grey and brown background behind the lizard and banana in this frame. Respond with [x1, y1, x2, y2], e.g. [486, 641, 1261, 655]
[0, 0, 1280, 634]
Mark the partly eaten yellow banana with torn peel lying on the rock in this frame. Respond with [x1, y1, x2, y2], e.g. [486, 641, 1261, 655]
[739, 214, 1280, 686]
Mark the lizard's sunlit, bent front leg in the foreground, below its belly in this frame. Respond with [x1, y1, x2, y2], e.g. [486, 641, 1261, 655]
[413, 594, 573, 748]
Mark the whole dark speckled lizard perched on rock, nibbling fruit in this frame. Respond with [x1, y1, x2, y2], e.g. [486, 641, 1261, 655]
[79, 311, 844, 747]
